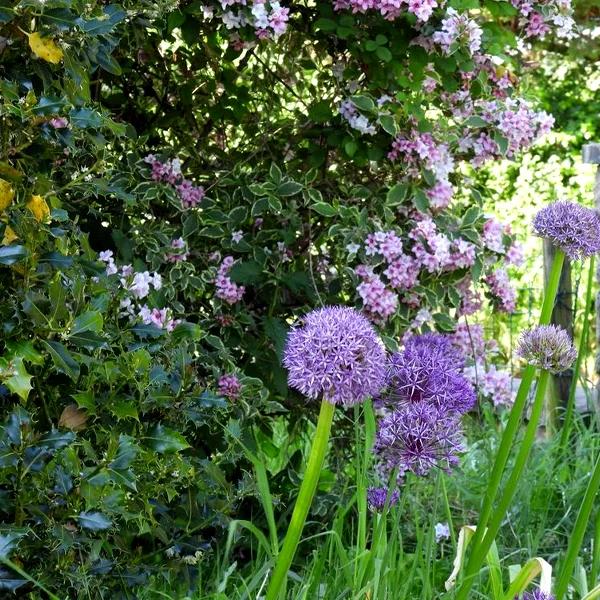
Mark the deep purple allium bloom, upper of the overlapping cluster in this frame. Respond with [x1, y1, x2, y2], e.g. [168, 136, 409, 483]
[387, 334, 477, 414]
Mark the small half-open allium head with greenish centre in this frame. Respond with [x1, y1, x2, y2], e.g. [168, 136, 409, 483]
[517, 325, 577, 373]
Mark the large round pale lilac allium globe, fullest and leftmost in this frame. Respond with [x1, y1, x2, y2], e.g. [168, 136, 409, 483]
[283, 306, 386, 405]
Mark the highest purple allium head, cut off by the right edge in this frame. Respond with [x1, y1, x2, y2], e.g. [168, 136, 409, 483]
[533, 201, 600, 260]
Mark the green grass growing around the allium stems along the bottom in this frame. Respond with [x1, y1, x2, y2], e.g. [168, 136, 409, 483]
[135, 409, 600, 600]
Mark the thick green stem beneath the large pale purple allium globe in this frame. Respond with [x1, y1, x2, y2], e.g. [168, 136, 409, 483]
[266, 400, 335, 600]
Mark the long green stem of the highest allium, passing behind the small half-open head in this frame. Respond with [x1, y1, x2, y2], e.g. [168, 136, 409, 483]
[457, 250, 565, 600]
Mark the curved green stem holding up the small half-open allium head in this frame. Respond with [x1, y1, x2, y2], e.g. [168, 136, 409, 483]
[456, 371, 550, 600]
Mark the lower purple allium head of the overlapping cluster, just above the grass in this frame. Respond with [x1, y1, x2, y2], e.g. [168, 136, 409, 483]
[375, 402, 463, 476]
